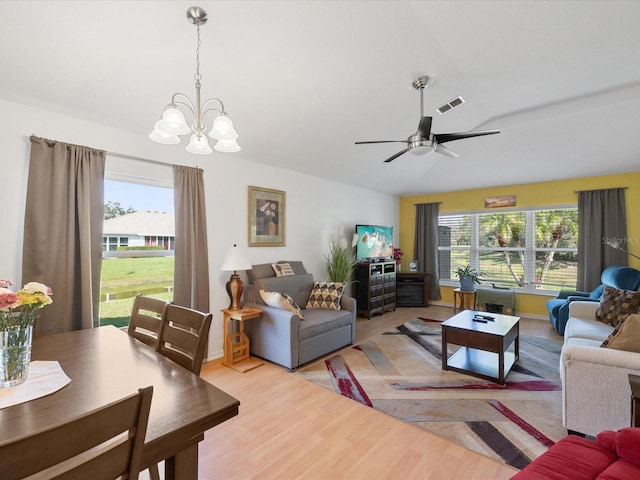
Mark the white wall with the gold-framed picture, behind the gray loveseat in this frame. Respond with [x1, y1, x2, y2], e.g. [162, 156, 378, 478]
[0, 99, 399, 358]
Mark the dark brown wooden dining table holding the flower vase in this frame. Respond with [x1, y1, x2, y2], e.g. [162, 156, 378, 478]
[0, 326, 240, 480]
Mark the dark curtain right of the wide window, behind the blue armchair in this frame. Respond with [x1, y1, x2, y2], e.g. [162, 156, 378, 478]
[577, 188, 629, 291]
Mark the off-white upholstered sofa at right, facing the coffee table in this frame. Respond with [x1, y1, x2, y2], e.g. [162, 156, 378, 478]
[560, 301, 640, 436]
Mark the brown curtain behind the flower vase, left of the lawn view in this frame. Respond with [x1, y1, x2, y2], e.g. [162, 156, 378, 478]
[22, 137, 105, 334]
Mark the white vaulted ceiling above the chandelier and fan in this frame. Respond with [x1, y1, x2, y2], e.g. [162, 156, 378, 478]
[0, 0, 640, 196]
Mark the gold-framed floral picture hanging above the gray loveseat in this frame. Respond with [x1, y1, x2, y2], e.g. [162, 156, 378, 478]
[248, 186, 286, 247]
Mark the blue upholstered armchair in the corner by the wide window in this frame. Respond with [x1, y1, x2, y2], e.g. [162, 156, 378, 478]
[547, 265, 640, 335]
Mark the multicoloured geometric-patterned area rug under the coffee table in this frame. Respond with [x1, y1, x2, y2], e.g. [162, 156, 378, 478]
[295, 318, 566, 469]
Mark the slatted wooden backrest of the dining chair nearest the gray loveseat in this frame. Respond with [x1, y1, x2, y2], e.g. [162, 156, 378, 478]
[158, 304, 212, 375]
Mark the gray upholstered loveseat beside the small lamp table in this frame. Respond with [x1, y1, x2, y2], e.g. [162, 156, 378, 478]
[242, 261, 356, 371]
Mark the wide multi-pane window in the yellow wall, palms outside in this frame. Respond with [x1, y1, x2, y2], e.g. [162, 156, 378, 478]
[438, 208, 578, 290]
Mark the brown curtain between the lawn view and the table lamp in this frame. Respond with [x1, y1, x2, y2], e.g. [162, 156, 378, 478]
[173, 165, 209, 312]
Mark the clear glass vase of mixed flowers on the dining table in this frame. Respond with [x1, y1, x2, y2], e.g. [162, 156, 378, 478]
[0, 280, 53, 387]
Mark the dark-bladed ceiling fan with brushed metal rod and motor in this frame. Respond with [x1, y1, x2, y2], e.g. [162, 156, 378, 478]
[356, 76, 500, 163]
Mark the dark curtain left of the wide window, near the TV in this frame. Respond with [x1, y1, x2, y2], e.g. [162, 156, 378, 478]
[413, 203, 442, 300]
